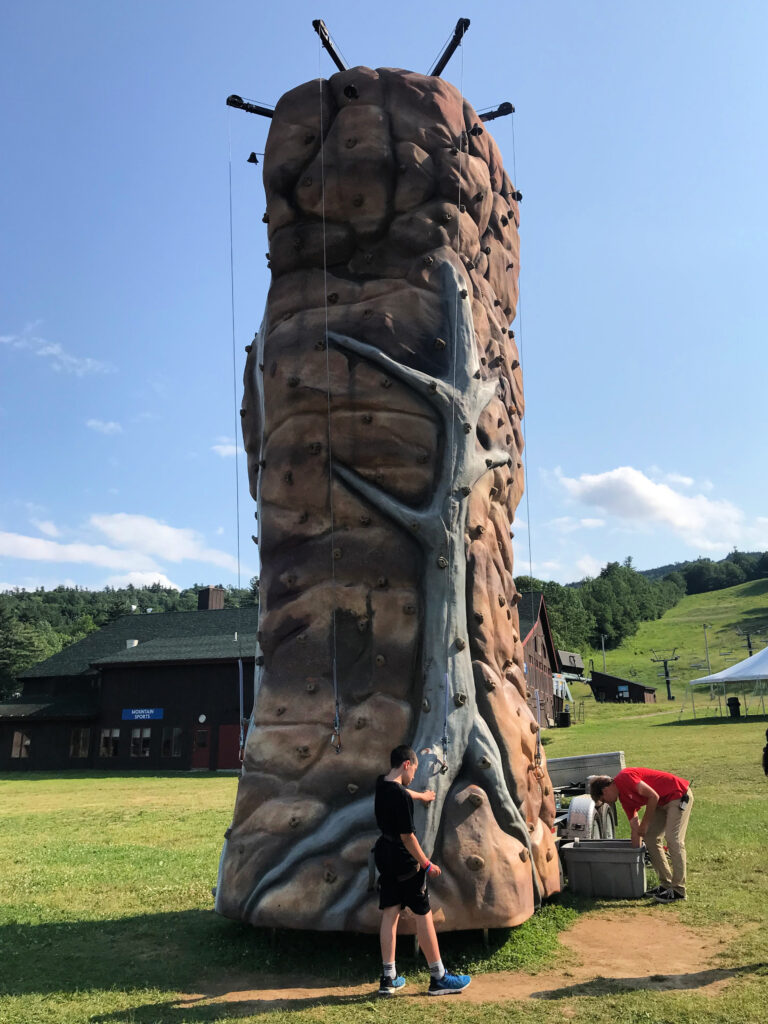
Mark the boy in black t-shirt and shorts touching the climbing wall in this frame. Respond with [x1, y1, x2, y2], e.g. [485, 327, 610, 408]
[374, 745, 471, 995]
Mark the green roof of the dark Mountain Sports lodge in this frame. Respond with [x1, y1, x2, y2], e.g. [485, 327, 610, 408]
[18, 604, 259, 679]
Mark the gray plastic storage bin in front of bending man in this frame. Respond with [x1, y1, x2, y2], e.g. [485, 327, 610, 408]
[560, 839, 645, 899]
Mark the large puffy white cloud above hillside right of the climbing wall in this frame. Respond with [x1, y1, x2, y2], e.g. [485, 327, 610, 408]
[557, 466, 768, 551]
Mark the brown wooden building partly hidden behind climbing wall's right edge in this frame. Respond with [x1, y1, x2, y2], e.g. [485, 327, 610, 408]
[517, 591, 563, 729]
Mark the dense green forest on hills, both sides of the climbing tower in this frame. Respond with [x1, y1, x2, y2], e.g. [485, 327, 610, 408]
[0, 551, 768, 697]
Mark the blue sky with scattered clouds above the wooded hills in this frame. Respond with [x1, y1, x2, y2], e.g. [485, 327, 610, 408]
[0, 0, 768, 588]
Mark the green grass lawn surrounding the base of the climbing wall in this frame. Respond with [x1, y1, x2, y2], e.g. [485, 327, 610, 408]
[0, 707, 768, 1024]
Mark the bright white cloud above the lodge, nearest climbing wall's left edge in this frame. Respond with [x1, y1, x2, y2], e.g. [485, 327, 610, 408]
[89, 512, 238, 571]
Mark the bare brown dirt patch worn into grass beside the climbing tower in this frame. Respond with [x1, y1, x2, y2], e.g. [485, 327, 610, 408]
[180, 907, 750, 1013]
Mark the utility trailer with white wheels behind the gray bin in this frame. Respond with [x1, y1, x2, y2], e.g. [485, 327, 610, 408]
[547, 751, 627, 841]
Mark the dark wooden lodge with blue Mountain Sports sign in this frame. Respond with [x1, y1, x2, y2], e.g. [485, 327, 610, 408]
[0, 587, 258, 771]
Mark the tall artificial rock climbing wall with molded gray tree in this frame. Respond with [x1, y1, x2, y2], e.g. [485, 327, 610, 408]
[216, 61, 559, 931]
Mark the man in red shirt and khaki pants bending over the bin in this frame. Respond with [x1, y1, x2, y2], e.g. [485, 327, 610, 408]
[590, 768, 693, 903]
